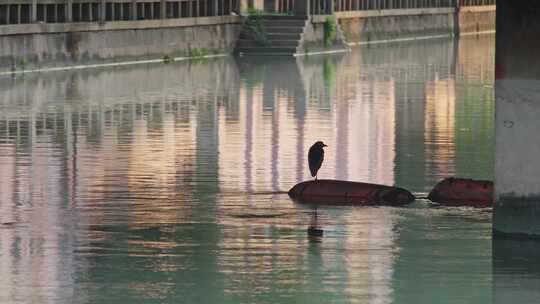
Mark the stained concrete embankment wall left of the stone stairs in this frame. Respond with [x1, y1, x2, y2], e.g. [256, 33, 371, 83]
[0, 16, 241, 72]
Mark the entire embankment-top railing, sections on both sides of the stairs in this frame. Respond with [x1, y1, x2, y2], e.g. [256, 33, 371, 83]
[0, 0, 495, 25]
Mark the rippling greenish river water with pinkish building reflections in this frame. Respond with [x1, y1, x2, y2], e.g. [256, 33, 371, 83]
[0, 36, 494, 303]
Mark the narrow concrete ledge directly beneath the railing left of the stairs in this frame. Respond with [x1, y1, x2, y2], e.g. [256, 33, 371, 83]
[0, 16, 242, 36]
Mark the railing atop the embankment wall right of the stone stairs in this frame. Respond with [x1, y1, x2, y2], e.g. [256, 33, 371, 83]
[309, 0, 495, 15]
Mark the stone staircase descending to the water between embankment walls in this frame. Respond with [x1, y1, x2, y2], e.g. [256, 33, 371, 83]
[235, 15, 307, 56]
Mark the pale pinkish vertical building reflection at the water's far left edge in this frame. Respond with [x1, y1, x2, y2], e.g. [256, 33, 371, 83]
[0, 127, 79, 303]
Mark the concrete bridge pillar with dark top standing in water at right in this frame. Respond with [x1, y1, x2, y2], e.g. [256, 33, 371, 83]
[493, 0, 540, 238]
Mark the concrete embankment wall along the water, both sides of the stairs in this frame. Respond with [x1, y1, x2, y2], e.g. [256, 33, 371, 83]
[0, 6, 495, 73]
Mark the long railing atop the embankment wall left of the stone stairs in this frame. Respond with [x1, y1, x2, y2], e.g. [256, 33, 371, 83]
[0, 0, 238, 25]
